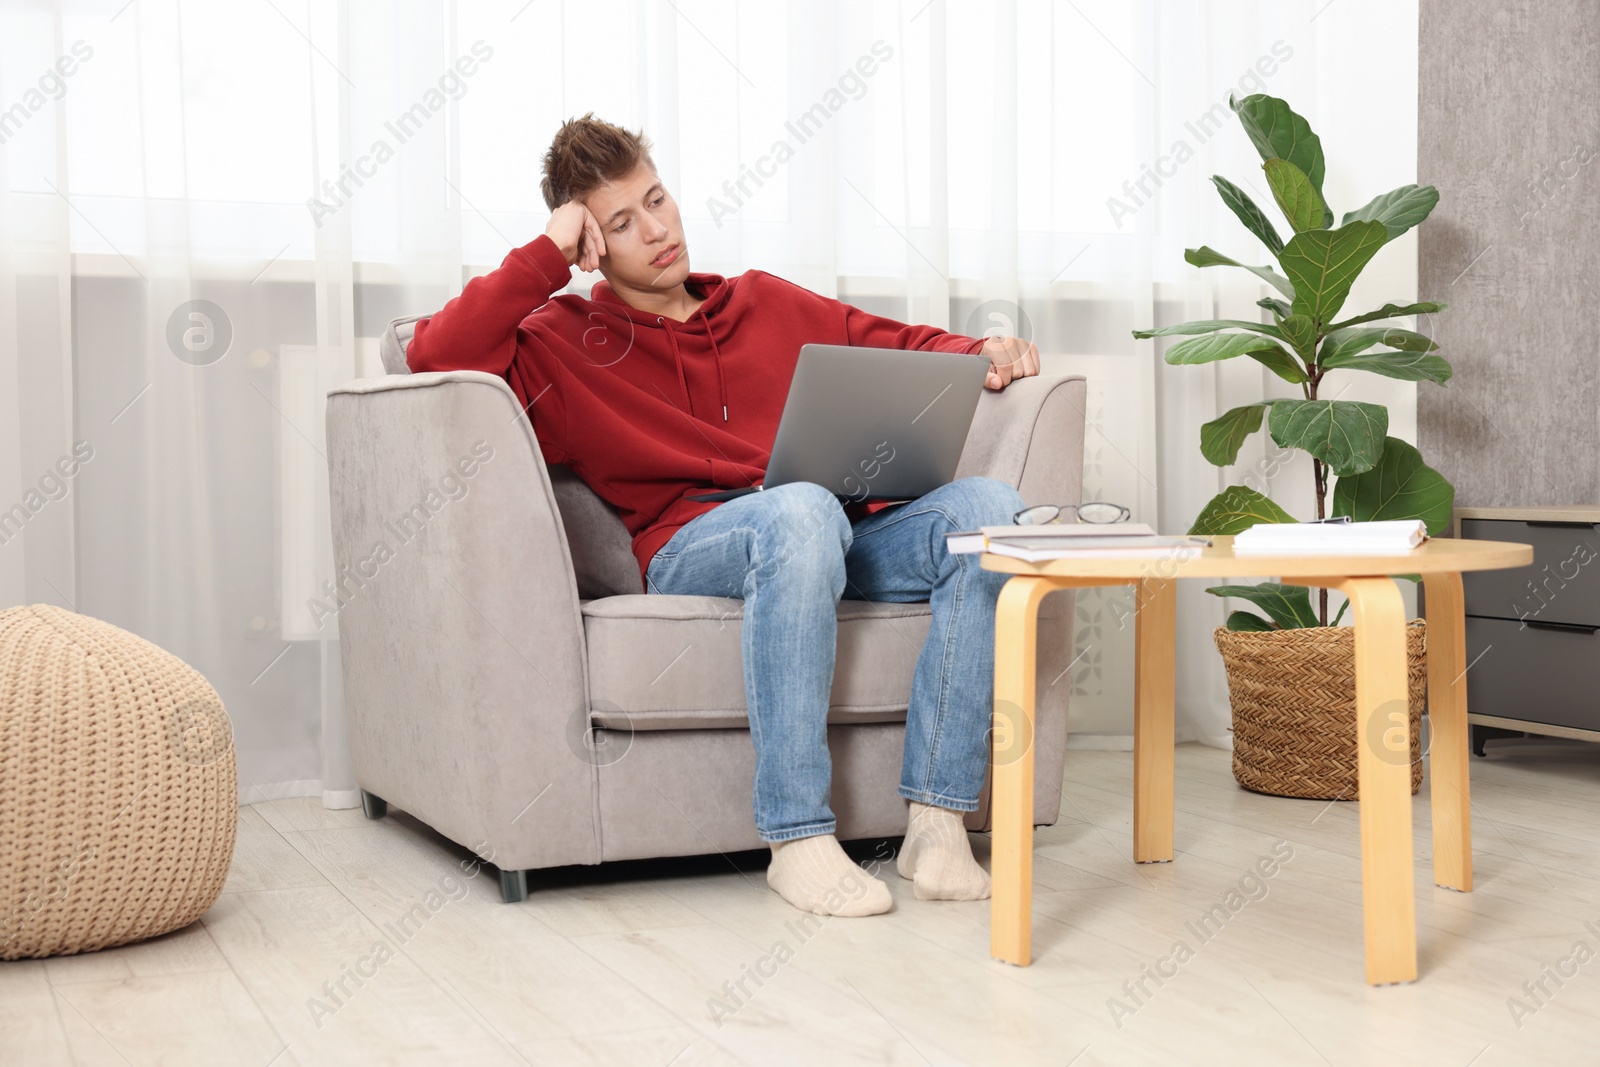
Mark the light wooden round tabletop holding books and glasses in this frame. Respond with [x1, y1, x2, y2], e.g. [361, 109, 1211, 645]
[982, 536, 1533, 581]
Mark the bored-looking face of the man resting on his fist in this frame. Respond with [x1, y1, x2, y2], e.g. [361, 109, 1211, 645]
[584, 163, 690, 290]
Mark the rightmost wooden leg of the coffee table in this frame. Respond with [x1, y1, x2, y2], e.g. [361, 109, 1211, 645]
[1422, 573, 1472, 893]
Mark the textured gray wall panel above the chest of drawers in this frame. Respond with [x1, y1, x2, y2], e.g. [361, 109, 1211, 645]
[1418, 0, 1600, 507]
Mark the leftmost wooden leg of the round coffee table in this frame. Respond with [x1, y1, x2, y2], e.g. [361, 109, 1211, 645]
[989, 574, 1059, 966]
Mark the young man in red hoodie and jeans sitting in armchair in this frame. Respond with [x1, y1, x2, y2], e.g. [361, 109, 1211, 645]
[406, 115, 1038, 915]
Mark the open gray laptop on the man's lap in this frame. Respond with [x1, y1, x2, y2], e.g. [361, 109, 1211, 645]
[688, 344, 989, 502]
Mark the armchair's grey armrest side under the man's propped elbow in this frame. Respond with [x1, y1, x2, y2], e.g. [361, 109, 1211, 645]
[326, 371, 600, 870]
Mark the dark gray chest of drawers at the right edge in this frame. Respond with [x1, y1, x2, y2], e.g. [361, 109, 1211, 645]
[1456, 507, 1600, 755]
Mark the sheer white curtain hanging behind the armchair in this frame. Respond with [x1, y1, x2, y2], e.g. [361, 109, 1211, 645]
[0, 0, 1416, 806]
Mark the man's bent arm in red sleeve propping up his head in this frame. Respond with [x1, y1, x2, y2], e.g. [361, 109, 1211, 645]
[405, 200, 605, 378]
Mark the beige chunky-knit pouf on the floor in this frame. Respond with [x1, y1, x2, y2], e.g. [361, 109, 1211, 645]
[0, 605, 238, 960]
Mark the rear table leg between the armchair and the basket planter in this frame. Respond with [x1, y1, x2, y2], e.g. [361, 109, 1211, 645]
[1133, 577, 1178, 864]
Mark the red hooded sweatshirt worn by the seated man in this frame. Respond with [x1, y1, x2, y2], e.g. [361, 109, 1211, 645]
[406, 235, 982, 591]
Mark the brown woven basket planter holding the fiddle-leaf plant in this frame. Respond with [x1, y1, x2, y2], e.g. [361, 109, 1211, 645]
[1216, 619, 1427, 800]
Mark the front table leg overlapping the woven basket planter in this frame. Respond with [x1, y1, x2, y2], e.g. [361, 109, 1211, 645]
[1339, 577, 1416, 985]
